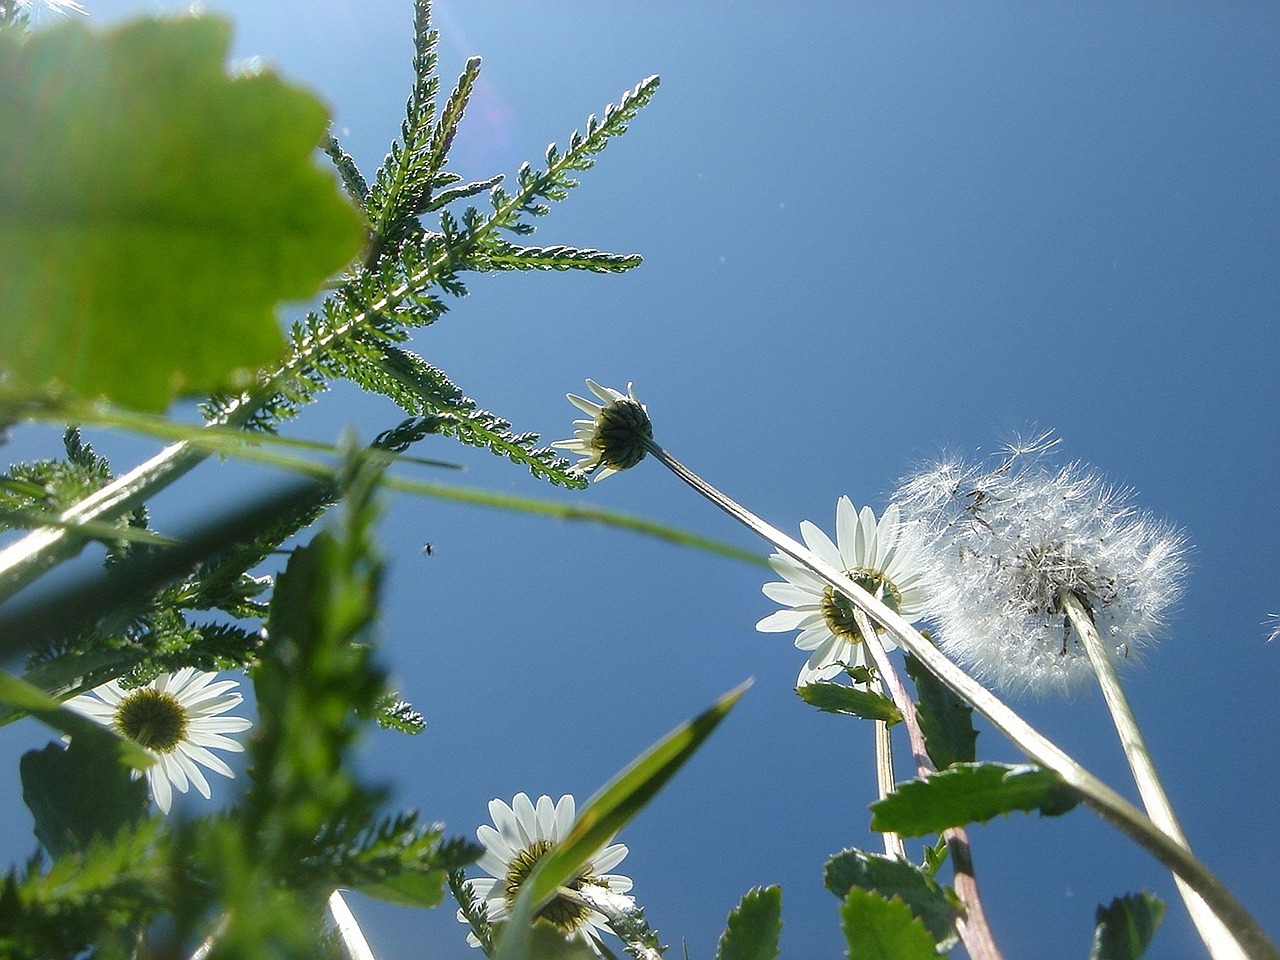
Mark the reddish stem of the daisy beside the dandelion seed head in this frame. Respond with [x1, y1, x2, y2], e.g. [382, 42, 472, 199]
[854, 607, 1004, 960]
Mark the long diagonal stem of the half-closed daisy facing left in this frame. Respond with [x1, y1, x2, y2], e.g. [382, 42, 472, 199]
[645, 439, 1280, 960]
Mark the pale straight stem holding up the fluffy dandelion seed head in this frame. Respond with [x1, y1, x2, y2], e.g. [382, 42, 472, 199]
[1059, 591, 1244, 960]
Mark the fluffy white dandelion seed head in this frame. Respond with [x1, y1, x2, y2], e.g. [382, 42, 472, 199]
[895, 436, 1187, 694]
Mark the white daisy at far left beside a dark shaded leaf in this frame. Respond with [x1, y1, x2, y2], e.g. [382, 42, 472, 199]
[65, 667, 253, 813]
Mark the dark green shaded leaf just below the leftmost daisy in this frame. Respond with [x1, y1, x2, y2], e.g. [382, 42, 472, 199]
[18, 736, 147, 858]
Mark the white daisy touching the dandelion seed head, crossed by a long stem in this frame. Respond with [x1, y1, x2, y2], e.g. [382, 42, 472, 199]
[755, 497, 924, 686]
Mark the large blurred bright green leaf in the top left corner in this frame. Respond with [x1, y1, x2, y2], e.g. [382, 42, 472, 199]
[0, 17, 364, 410]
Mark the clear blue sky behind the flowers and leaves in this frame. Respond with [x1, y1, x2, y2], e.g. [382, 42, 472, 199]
[0, 0, 1280, 960]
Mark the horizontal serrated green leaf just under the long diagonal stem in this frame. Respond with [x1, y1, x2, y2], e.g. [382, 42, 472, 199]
[872, 763, 1078, 837]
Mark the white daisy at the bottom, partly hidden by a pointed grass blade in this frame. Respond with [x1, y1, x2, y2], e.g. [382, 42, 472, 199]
[458, 794, 631, 955]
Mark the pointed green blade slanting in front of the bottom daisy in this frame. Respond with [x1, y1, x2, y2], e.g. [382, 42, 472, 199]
[494, 681, 751, 960]
